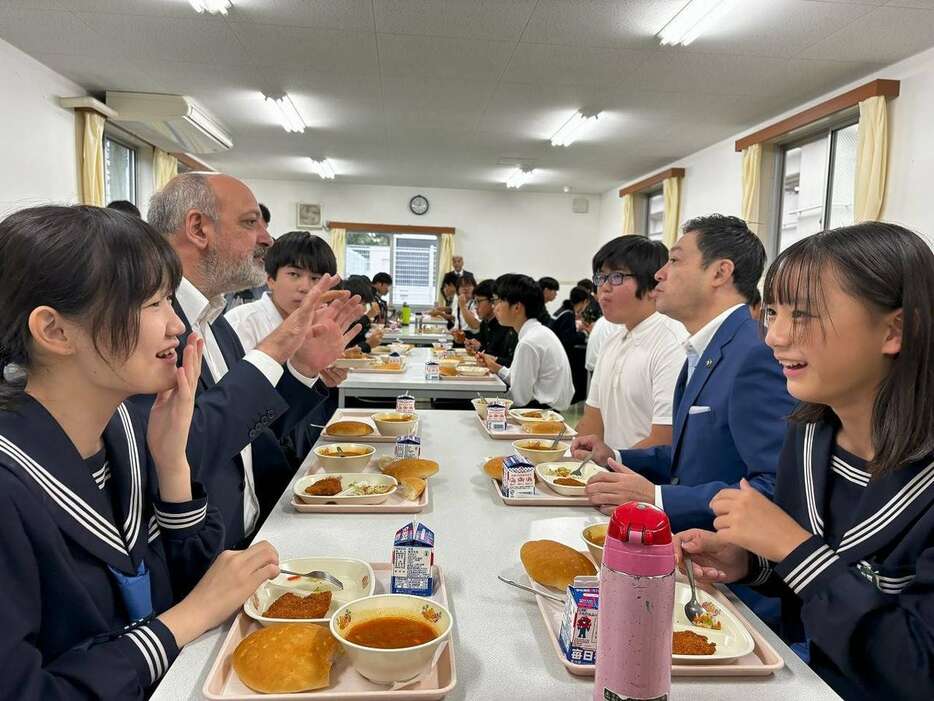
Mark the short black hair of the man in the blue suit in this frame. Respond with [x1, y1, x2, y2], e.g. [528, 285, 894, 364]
[682, 214, 766, 301]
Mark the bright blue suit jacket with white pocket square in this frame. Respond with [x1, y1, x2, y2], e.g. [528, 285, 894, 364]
[620, 305, 794, 532]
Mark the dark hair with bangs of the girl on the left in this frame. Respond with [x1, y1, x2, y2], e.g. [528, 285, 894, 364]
[0, 206, 182, 407]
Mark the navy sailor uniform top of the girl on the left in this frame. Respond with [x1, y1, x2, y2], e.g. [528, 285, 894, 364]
[0, 396, 224, 701]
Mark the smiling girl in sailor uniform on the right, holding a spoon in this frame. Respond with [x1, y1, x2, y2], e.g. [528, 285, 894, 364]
[679, 222, 934, 701]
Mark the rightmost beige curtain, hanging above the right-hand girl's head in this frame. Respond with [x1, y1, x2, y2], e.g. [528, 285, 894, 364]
[853, 96, 889, 223]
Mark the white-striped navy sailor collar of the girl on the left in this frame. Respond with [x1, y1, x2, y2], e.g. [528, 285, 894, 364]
[0, 395, 151, 574]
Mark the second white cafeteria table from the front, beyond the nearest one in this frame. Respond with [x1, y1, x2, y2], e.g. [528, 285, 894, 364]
[337, 348, 507, 407]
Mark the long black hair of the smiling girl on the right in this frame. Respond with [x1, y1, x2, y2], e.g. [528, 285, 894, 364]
[765, 222, 934, 474]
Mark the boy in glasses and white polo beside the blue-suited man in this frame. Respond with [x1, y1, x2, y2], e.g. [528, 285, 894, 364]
[575, 235, 687, 448]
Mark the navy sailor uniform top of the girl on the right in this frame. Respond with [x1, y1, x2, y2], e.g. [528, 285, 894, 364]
[748, 423, 934, 701]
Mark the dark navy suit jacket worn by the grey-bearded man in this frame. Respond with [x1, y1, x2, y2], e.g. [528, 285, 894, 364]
[131, 303, 326, 548]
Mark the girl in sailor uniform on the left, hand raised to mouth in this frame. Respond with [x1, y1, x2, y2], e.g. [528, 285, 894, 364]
[0, 207, 278, 701]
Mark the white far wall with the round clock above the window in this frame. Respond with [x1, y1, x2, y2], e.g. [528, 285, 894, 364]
[245, 178, 600, 298]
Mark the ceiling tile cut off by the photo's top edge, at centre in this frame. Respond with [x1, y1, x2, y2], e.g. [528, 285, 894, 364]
[374, 0, 535, 40]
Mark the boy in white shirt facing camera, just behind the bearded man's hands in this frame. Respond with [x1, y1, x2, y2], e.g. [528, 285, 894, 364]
[224, 231, 347, 460]
